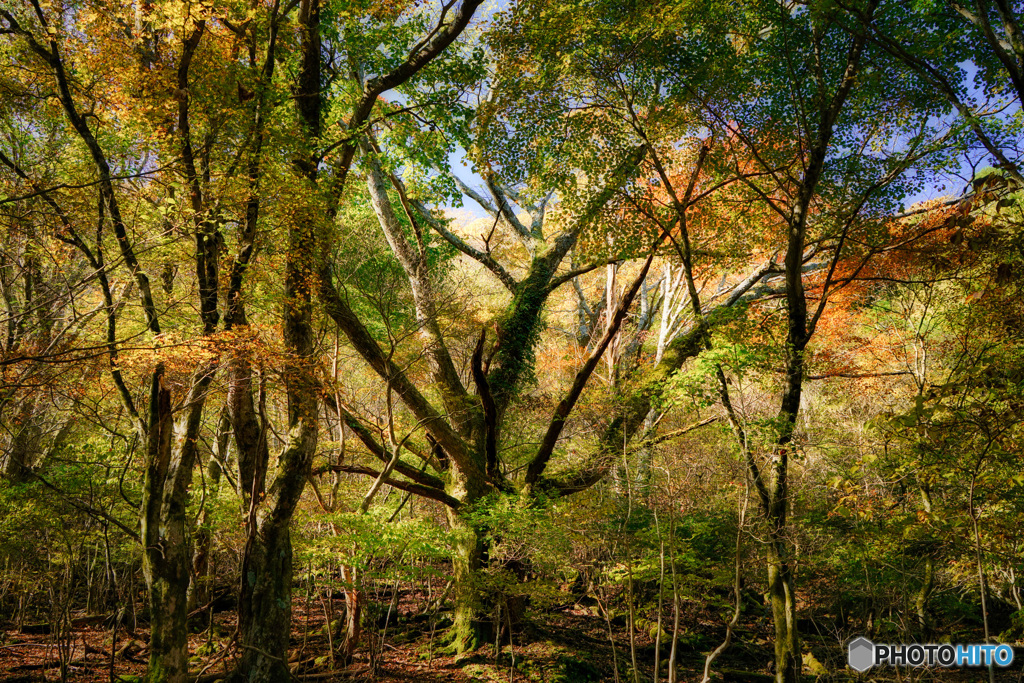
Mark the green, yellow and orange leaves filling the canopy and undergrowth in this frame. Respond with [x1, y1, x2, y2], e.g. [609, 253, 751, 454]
[6, 0, 1024, 683]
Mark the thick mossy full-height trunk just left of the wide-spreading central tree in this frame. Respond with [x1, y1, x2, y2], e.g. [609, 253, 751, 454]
[229, 0, 325, 683]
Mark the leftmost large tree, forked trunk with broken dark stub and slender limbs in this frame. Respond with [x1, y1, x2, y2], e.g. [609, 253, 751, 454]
[3, 4, 225, 681]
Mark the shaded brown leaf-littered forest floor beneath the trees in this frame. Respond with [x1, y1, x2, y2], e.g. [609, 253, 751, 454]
[0, 591, 1024, 683]
